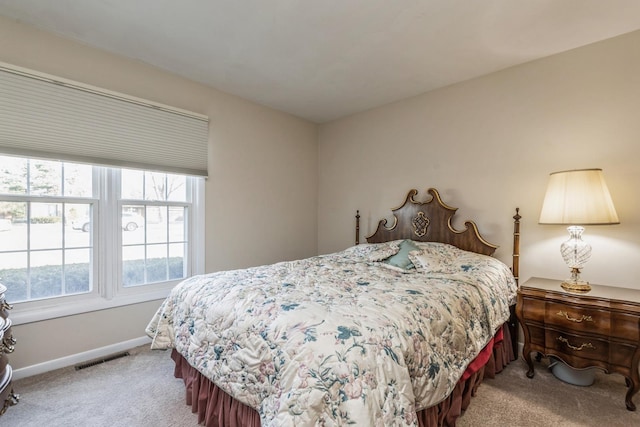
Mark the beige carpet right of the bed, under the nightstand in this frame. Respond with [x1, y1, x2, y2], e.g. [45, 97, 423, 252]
[458, 359, 640, 427]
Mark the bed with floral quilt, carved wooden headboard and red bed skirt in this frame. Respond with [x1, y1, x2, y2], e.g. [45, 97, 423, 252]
[146, 188, 520, 427]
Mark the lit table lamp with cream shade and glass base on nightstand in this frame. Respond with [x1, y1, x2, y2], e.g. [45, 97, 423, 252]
[539, 169, 620, 292]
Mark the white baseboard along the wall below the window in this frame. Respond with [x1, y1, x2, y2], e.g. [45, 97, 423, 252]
[13, 336, 151, 380]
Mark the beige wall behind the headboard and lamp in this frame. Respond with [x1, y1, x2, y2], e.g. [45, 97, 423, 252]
[318, 32, 640, 289]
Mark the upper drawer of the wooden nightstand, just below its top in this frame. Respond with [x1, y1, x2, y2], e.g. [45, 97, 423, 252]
[544, 302, 611, 336]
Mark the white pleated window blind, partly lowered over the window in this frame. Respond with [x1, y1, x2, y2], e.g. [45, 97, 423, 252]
[0, 63, 209, 176]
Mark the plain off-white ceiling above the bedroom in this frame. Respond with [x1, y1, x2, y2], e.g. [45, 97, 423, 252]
[0, 0, 640, 123]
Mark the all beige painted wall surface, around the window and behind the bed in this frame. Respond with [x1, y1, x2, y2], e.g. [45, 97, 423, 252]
[5, 18, 640, 368]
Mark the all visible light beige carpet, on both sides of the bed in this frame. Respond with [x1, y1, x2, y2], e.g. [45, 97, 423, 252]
[0, 346, 640, 427]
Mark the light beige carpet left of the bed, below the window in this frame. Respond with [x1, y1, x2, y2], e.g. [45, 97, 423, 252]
[0, 346, 198, 427]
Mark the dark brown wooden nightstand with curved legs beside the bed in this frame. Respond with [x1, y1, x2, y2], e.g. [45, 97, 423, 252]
[516, 277, 640, 411]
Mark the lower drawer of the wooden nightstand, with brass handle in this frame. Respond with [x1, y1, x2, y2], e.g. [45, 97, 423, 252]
[545, 329, 609, 362]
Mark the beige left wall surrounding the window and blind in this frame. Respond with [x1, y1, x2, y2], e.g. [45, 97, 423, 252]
[0, 17, 317, 369]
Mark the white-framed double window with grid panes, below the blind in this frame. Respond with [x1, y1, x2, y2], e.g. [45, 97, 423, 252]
[0, 156, 203, 319]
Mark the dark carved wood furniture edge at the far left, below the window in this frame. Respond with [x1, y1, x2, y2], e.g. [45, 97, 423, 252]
[0, 284, 20, 415]
